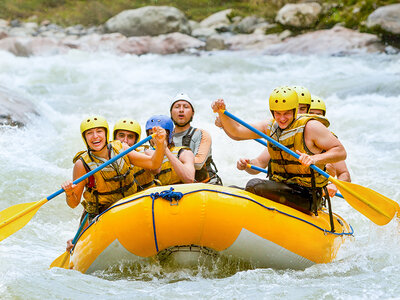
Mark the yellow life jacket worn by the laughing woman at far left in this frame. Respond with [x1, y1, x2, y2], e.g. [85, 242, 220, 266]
[73, 141, 137, 214]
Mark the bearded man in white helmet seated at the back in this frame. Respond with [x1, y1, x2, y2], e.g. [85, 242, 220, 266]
[170, 93, 222, 185]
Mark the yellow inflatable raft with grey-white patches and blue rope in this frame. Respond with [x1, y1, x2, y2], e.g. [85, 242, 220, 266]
[65, 183, 353, 273]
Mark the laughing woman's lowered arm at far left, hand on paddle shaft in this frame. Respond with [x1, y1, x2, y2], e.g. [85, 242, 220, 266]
[61, 159, 88, 208]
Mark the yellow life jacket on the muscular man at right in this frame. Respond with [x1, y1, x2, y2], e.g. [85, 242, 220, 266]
[267, 115, 329, 187]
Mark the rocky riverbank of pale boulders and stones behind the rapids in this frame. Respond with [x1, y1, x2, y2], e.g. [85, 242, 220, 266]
[0, 2, 400, 56]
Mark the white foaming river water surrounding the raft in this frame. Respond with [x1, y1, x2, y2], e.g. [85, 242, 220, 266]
[0, 51, 400, 299]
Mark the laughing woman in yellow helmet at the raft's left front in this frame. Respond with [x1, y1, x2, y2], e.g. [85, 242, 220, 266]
[61, 116, 165, 217]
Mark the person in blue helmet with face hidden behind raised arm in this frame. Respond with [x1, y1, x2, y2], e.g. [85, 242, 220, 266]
[146, 115, 195, 185]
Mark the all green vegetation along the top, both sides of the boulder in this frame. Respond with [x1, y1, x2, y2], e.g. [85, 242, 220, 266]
[0, 0, 398, 31]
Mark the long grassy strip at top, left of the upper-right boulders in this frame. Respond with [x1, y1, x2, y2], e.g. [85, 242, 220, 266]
[0, 0, 293, 26]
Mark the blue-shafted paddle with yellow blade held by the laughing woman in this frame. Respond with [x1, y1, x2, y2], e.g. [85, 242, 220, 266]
[0, 133, 155, 241]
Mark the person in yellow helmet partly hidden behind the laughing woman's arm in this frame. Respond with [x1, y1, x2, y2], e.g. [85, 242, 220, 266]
[113, 118, 158, 191]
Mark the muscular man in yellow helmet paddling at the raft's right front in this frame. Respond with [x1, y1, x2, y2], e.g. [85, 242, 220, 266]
[212, 86, 346, 213]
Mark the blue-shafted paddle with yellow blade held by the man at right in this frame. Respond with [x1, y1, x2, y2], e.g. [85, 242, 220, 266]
[221, 110, 400, 225]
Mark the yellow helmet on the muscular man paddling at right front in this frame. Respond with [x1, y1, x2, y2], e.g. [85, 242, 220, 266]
[269, 86, 299, 118]
